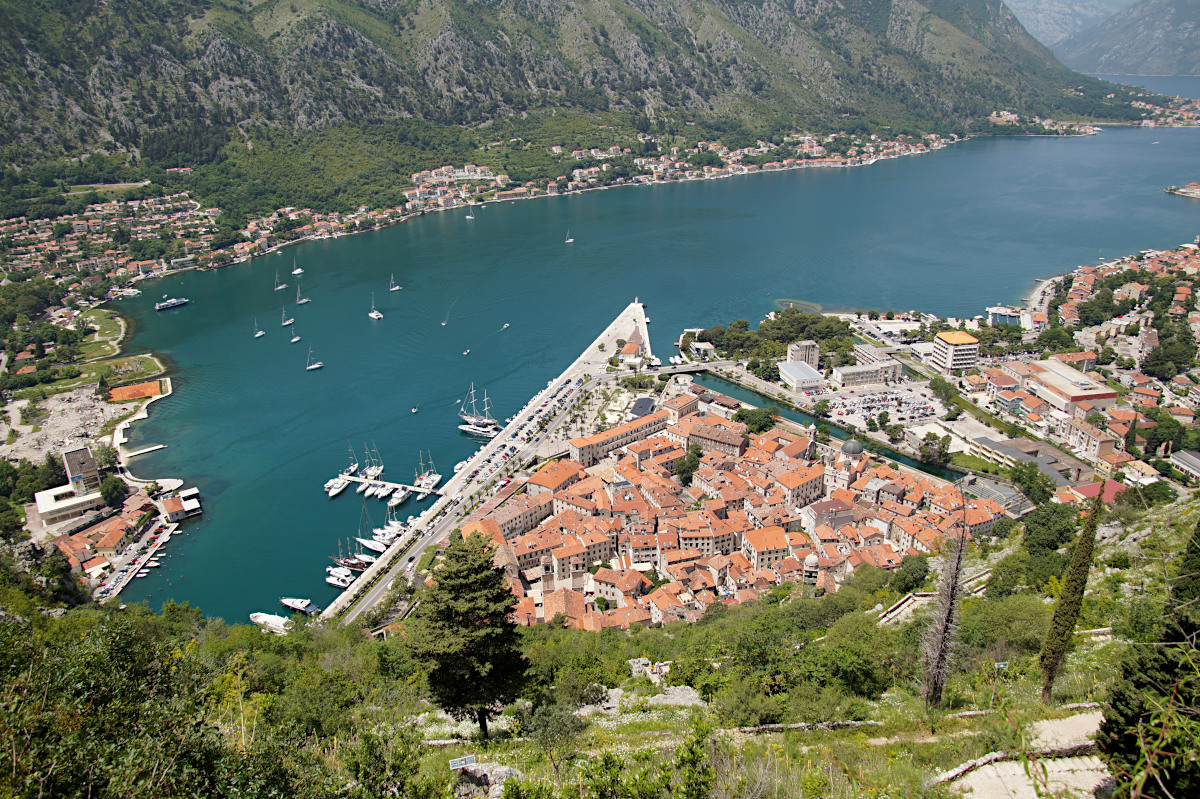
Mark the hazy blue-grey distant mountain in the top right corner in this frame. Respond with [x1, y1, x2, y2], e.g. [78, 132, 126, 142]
[1055, 0, 1200, 74]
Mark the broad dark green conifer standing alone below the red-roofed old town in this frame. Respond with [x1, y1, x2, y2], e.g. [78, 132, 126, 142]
[409, 534, 528, 739]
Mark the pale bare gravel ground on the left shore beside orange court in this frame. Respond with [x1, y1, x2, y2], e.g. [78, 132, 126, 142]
[0, 386, 137, 463]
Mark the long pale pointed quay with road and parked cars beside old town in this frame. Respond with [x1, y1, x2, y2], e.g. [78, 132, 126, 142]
[322, 298, 653, 623]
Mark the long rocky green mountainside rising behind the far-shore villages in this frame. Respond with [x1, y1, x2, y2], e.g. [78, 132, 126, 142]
[0, 0, 1142, 163]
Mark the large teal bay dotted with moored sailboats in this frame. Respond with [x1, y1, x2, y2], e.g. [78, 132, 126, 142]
[116, 128, 1200, 621]
